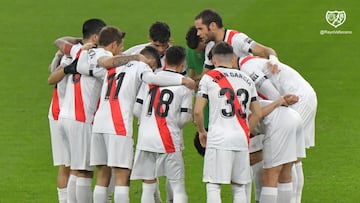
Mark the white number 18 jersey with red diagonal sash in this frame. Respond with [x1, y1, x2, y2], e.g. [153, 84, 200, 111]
[136, 70, 193, 153]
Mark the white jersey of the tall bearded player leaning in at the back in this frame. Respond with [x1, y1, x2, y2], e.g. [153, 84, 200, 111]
[204, 29, 256, 66]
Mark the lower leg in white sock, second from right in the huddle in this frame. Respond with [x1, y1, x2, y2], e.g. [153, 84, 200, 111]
[277, 162, 293, 203]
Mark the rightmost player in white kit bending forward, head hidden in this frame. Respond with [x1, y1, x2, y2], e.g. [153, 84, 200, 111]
[239, 56, 317, 202]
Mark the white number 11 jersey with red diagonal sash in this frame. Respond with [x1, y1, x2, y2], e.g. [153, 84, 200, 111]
[93, 61, 152, 136]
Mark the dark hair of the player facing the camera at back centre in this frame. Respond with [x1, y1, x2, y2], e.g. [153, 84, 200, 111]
[149, 21, 171, 43]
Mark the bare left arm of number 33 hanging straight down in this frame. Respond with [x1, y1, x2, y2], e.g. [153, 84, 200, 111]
[194, 93, 208, 147]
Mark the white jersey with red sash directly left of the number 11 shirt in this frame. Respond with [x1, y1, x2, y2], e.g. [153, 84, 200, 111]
[59, 46, 112, 123]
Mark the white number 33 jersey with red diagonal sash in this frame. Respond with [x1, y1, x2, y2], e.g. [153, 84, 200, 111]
[198, 67, 257, 150]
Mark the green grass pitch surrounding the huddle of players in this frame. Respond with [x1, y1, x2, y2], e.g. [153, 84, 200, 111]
[0, 0, 360, 203]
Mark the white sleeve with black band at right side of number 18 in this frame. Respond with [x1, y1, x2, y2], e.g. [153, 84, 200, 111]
[178, 91, 193, 129]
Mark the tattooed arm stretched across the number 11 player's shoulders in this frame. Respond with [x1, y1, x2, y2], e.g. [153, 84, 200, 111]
[98, 54, 148, 69]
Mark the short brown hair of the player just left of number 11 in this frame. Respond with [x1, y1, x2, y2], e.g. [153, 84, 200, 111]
[99, 26, 125, 46]
